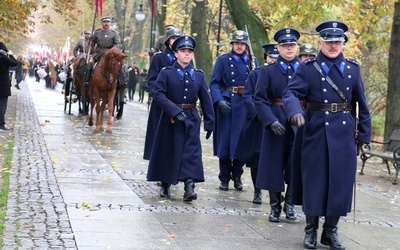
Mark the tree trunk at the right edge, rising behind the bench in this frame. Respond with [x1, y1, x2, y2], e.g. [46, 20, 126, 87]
[385, 1, 400, 140]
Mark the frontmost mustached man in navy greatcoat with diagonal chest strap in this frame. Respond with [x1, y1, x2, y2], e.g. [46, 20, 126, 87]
[283, 21, 371, 249]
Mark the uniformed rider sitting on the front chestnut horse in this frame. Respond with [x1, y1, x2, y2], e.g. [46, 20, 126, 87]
[85, 16, 121, 86]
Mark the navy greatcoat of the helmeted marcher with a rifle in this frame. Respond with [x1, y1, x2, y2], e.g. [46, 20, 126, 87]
[210, 51, 253, 159]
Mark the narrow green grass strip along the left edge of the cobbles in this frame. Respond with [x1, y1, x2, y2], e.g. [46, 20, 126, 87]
[0, 139, 14, 248]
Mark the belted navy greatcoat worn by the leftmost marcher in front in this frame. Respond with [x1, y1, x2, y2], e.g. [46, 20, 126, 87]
[147, 62, 214, 184]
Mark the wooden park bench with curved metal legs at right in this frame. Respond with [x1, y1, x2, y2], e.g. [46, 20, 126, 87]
[360, 129, 400, 185]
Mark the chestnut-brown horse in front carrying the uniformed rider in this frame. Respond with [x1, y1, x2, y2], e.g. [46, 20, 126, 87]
[89, 48, 127, 133]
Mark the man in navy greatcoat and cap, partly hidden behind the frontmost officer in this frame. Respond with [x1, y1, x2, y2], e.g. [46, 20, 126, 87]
[254, 28, 300, 222]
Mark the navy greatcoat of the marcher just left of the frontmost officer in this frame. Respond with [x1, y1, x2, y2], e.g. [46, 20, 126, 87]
[254, 56, 300, 192]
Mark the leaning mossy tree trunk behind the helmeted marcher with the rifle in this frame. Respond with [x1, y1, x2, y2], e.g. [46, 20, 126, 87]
[225, 0, 269, 60]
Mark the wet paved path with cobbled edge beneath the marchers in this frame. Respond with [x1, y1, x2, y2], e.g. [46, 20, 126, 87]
[3, 78, 400, 250]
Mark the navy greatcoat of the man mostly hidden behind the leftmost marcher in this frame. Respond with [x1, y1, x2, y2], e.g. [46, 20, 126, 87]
[143, 47, 175, 160]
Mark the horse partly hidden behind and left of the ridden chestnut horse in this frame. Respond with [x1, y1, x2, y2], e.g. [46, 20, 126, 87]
[72, 55, 89, 115]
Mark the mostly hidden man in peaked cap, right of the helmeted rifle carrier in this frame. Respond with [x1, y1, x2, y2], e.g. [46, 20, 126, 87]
[235, 44, 279, 204]
